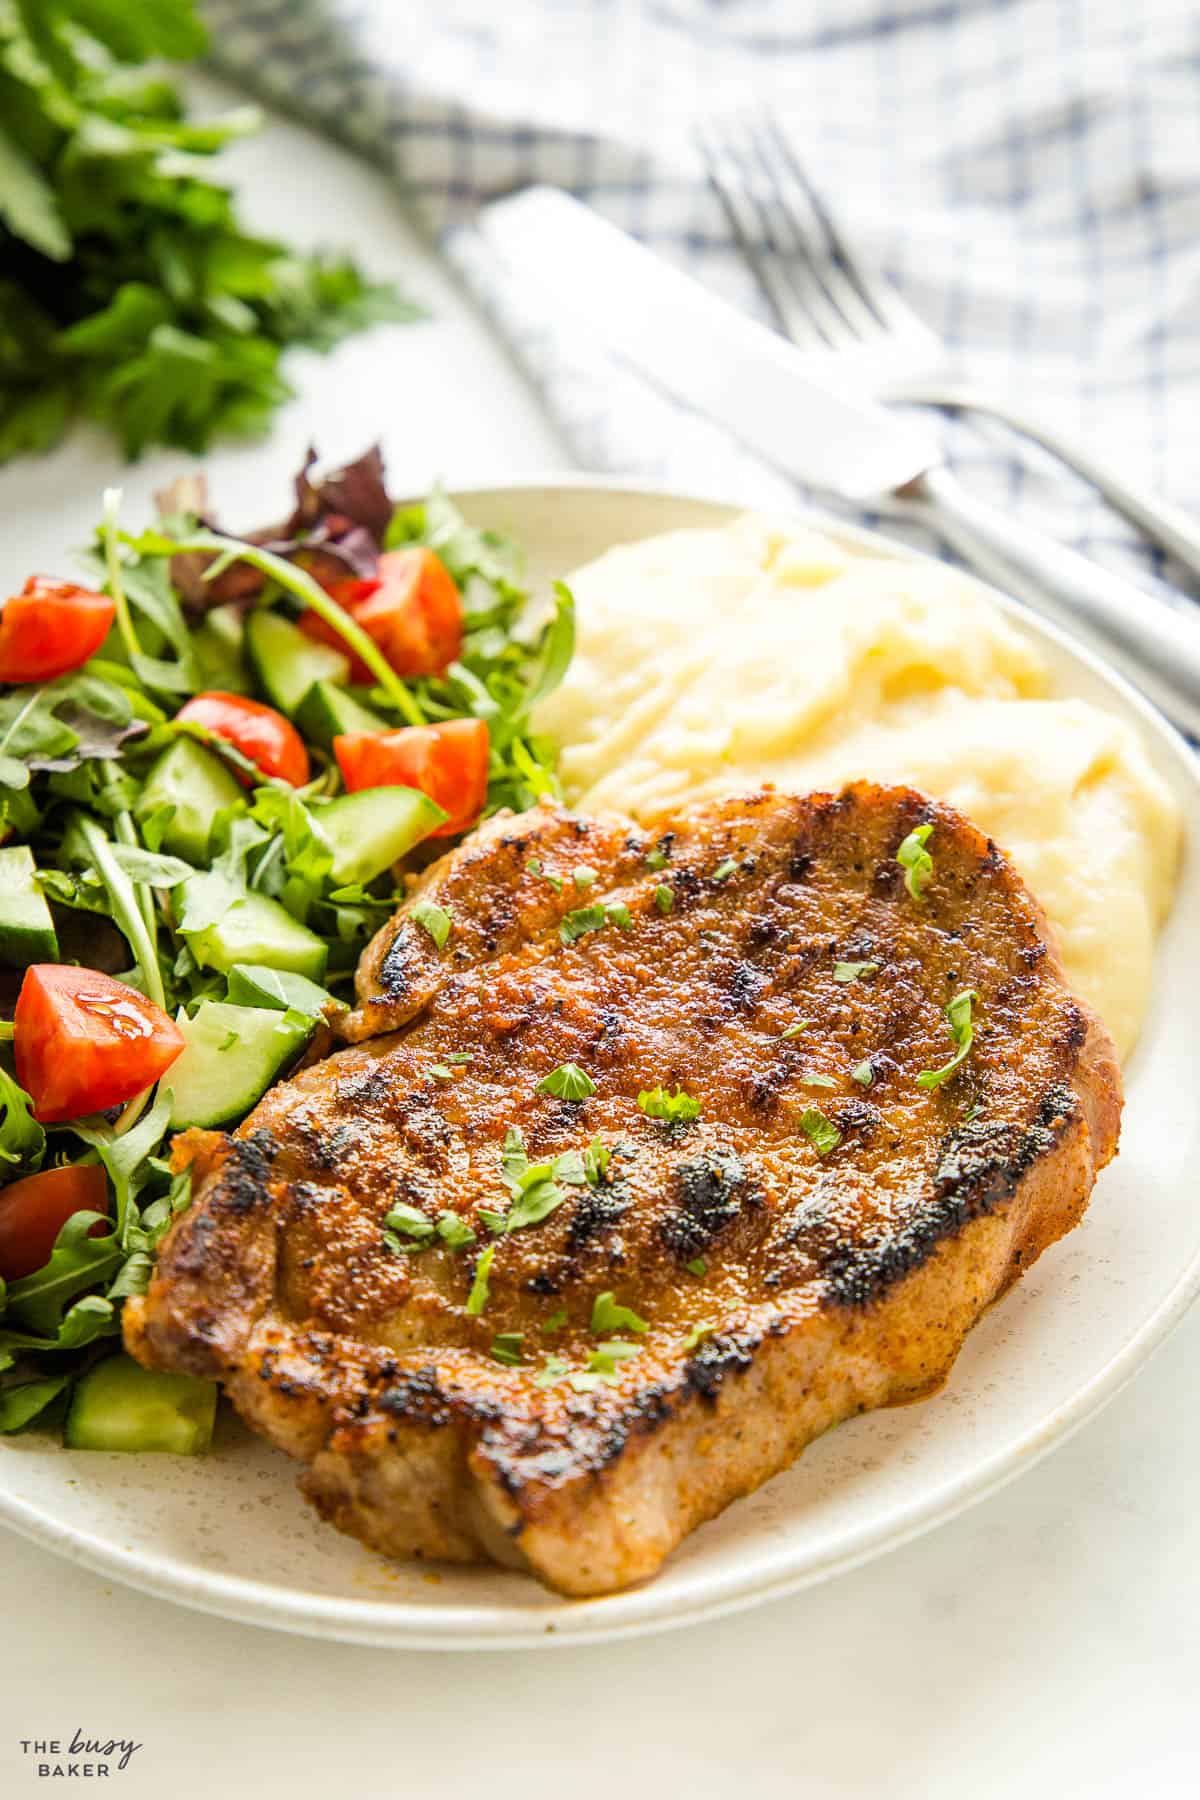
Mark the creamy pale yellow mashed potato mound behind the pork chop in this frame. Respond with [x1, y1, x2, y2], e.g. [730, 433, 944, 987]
[536, 518, 1178, 1055]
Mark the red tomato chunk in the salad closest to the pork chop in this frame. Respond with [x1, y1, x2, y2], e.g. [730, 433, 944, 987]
[333, 718, 488, 837]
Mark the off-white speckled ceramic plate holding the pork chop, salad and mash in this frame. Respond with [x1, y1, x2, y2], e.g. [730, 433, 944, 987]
[0, 479, 1200, 1649]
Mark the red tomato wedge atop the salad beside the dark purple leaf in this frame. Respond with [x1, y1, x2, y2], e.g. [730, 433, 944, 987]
[300, 545, 462, 682]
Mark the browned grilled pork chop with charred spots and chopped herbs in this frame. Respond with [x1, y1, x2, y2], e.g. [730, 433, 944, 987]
[124, 787, 1121, 1595]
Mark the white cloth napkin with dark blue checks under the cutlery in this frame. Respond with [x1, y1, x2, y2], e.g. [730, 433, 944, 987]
[205, 0, 1200, 594]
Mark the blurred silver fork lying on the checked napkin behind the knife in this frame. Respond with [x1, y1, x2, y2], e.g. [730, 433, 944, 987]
[698, 117, 1200, 578]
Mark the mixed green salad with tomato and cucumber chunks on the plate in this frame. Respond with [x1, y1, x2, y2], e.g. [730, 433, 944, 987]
[0, 452, 574, 1449]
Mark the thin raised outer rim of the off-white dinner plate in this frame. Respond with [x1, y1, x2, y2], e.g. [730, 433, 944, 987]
[0, 473, 1200, 1651]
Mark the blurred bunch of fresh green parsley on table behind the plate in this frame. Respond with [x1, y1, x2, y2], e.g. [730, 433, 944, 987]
[0, 0, 416, 463]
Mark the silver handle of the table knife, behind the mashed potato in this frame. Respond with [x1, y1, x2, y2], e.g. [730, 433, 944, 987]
[900, 468, 1200, 736]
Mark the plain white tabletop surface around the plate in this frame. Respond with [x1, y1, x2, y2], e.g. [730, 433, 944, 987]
[0, 81, 1200, 1800]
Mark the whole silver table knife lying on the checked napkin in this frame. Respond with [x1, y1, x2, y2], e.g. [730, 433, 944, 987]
[479, 187, 1200, 736]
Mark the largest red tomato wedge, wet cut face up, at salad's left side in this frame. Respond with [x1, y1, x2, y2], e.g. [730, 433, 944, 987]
[13, 963, 184, 1125]
